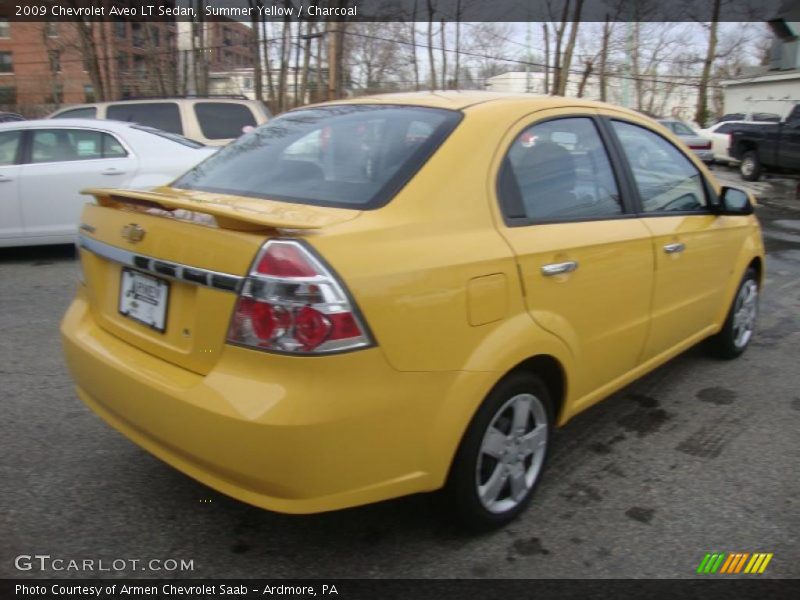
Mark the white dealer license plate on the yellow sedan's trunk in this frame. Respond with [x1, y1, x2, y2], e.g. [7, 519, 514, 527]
[119, 269, 169, 333]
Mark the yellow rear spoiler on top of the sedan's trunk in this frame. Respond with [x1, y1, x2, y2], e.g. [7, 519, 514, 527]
[81, 188, 360, 231]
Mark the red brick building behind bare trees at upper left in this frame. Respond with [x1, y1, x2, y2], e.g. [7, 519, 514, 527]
[0, 19, 253, 117]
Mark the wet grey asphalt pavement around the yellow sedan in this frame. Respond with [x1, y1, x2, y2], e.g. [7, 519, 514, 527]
[0, 169, 800, 578]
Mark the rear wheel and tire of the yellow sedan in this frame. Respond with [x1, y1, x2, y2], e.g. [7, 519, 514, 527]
[440, 372, 553, 531]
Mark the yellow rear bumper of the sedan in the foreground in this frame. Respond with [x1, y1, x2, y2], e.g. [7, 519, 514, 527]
[61, 293, 494, 513]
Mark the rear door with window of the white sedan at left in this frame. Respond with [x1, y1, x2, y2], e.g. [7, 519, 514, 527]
[19, 127, 138, 242]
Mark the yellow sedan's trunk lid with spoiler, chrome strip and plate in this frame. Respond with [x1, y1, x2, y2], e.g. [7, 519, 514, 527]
[79, 187, 360, 374]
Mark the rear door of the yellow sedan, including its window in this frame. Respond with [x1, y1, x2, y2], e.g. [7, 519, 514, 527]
[497, 110, 654, 405]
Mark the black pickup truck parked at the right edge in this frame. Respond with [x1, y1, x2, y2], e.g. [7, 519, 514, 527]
[728, 104, 800, 181]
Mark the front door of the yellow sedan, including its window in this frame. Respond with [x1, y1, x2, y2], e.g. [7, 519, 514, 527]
[609, 118, 747, 361]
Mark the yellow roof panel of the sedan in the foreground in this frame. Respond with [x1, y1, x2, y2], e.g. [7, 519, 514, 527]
[295, 90, 641, 116]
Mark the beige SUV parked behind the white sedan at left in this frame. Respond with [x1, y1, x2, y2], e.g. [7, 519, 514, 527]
[48, 97, 270, 146]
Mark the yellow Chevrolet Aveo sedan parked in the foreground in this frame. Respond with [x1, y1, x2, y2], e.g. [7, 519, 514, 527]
[62, 93, 764, 528]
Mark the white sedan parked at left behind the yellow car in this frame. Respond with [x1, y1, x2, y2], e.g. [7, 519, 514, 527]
[0, 119, 218, 247]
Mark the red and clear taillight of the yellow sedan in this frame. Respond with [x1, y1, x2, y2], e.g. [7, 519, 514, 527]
[228, 240, 372, 354]
